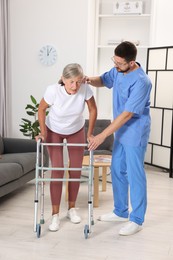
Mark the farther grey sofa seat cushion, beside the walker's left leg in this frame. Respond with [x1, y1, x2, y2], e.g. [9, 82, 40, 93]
[0, 153, 36, 174]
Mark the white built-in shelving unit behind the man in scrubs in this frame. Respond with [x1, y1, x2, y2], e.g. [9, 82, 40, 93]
[94, 0, 155, 119]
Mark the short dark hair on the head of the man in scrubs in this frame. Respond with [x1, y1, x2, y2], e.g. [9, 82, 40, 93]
[114, 41, 137, 62]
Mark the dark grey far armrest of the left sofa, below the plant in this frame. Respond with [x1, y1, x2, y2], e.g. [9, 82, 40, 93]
[3, 137, 37, 153]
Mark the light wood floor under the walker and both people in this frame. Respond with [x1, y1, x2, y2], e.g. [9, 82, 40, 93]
[0, 166, 173, 260]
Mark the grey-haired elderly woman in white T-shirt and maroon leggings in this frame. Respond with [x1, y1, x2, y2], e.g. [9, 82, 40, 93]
[36, 63, 97, 231]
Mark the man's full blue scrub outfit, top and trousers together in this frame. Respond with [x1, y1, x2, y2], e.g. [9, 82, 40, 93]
[101, 64, 151, 225]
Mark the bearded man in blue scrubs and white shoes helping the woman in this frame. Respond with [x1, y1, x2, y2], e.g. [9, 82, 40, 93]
[86, 41, 151, 236]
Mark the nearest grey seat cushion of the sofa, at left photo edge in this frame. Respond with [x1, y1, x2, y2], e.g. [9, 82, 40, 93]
[0, 163, 23, 186]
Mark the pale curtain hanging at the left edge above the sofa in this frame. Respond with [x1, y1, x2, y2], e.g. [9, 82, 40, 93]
[0, 0, 11, 137]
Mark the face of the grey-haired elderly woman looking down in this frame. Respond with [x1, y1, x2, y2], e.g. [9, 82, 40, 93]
[62, 76, 83, 95]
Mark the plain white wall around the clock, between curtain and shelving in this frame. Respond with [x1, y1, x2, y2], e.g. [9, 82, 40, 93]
[9, 0, 88, 137]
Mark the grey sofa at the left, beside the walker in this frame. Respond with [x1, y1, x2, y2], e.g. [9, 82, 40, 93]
[0, 136, 49, 197]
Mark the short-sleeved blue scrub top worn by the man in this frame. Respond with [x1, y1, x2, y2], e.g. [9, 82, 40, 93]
[101, 64, 151, 146]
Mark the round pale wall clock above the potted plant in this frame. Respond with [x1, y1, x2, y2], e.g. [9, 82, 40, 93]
[39, 45, 57, 66]
